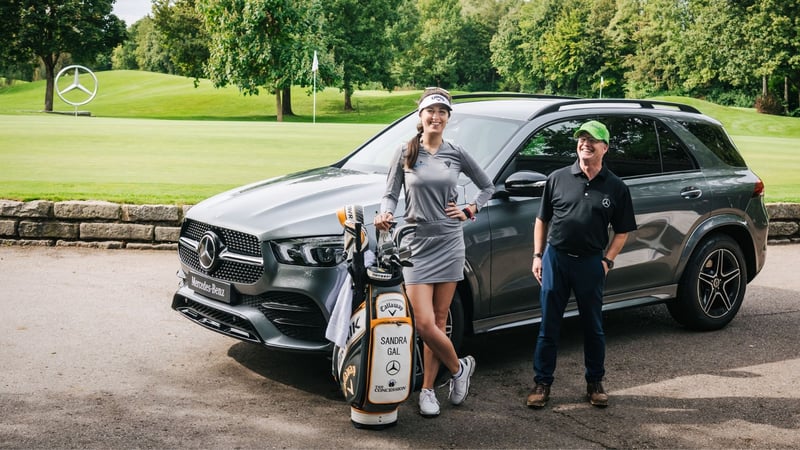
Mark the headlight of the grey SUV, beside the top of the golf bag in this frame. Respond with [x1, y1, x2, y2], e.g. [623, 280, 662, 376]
[272, 236, 344, 267]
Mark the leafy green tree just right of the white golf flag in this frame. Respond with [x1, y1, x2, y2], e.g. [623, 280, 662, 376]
[324, 0, 401, 111]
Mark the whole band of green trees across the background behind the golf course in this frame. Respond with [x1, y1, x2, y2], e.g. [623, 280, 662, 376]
[0, 0, 800, 118]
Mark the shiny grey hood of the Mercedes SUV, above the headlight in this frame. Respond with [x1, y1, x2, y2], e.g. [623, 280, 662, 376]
[186, 167, 386, 241]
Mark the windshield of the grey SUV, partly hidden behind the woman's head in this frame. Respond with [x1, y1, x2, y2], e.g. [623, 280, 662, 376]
[343, 108, 524, 173]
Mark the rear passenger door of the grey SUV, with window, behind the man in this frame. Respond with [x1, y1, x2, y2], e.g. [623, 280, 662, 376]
[597, 114, 711, 302]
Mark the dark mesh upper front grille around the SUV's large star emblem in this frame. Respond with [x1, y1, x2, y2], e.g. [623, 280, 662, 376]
[178, 219, 264, 284]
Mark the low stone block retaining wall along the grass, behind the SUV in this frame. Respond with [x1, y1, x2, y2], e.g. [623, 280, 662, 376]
[0, 200, 800, 250]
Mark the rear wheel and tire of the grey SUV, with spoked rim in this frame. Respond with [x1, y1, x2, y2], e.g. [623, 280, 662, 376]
[667, 235, 747, 331]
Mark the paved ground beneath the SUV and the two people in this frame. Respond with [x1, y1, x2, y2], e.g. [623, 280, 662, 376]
[0, 245, 800, 449]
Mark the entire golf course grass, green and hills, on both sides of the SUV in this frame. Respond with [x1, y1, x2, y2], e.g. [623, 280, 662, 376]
[0, 71, 800, 204]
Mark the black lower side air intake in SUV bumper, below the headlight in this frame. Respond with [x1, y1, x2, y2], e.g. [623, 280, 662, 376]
[242, 292, 327, 342]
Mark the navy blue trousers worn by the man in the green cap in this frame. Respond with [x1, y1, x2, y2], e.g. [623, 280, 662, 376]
[533, 246, 606, 384]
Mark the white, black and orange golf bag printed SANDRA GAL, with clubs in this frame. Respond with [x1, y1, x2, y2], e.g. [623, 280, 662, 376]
[332, 205, 421, 428]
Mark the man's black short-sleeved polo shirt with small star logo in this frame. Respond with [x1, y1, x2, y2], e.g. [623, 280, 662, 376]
[538, 160, 636, 255]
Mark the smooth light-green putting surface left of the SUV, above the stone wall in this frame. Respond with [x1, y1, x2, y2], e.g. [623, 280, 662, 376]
[0, 115, 381, 204]
